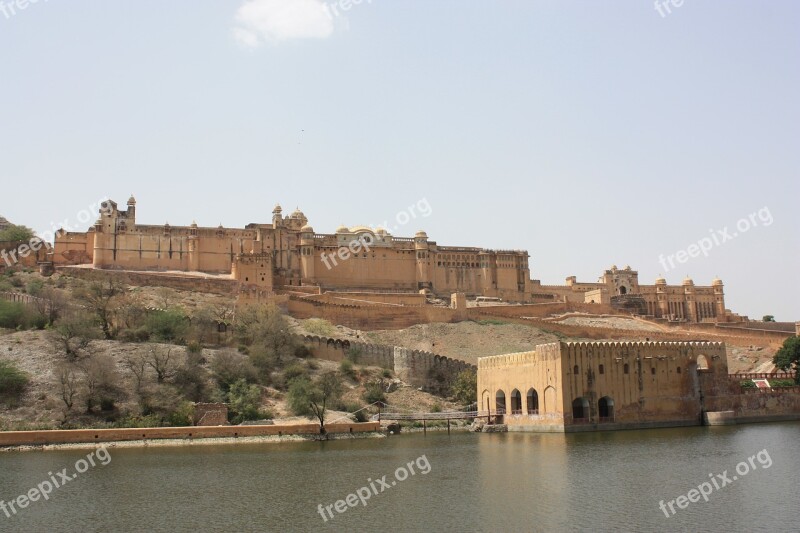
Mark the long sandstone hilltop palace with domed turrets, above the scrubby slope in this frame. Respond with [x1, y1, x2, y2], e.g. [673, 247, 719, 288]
[52, 197, 738, 322]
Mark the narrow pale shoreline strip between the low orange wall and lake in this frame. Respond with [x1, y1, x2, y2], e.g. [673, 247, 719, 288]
[0, 431, 386, 453]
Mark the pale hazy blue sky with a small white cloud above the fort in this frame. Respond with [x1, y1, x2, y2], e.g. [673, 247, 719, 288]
[0, 0, 800, 320]
